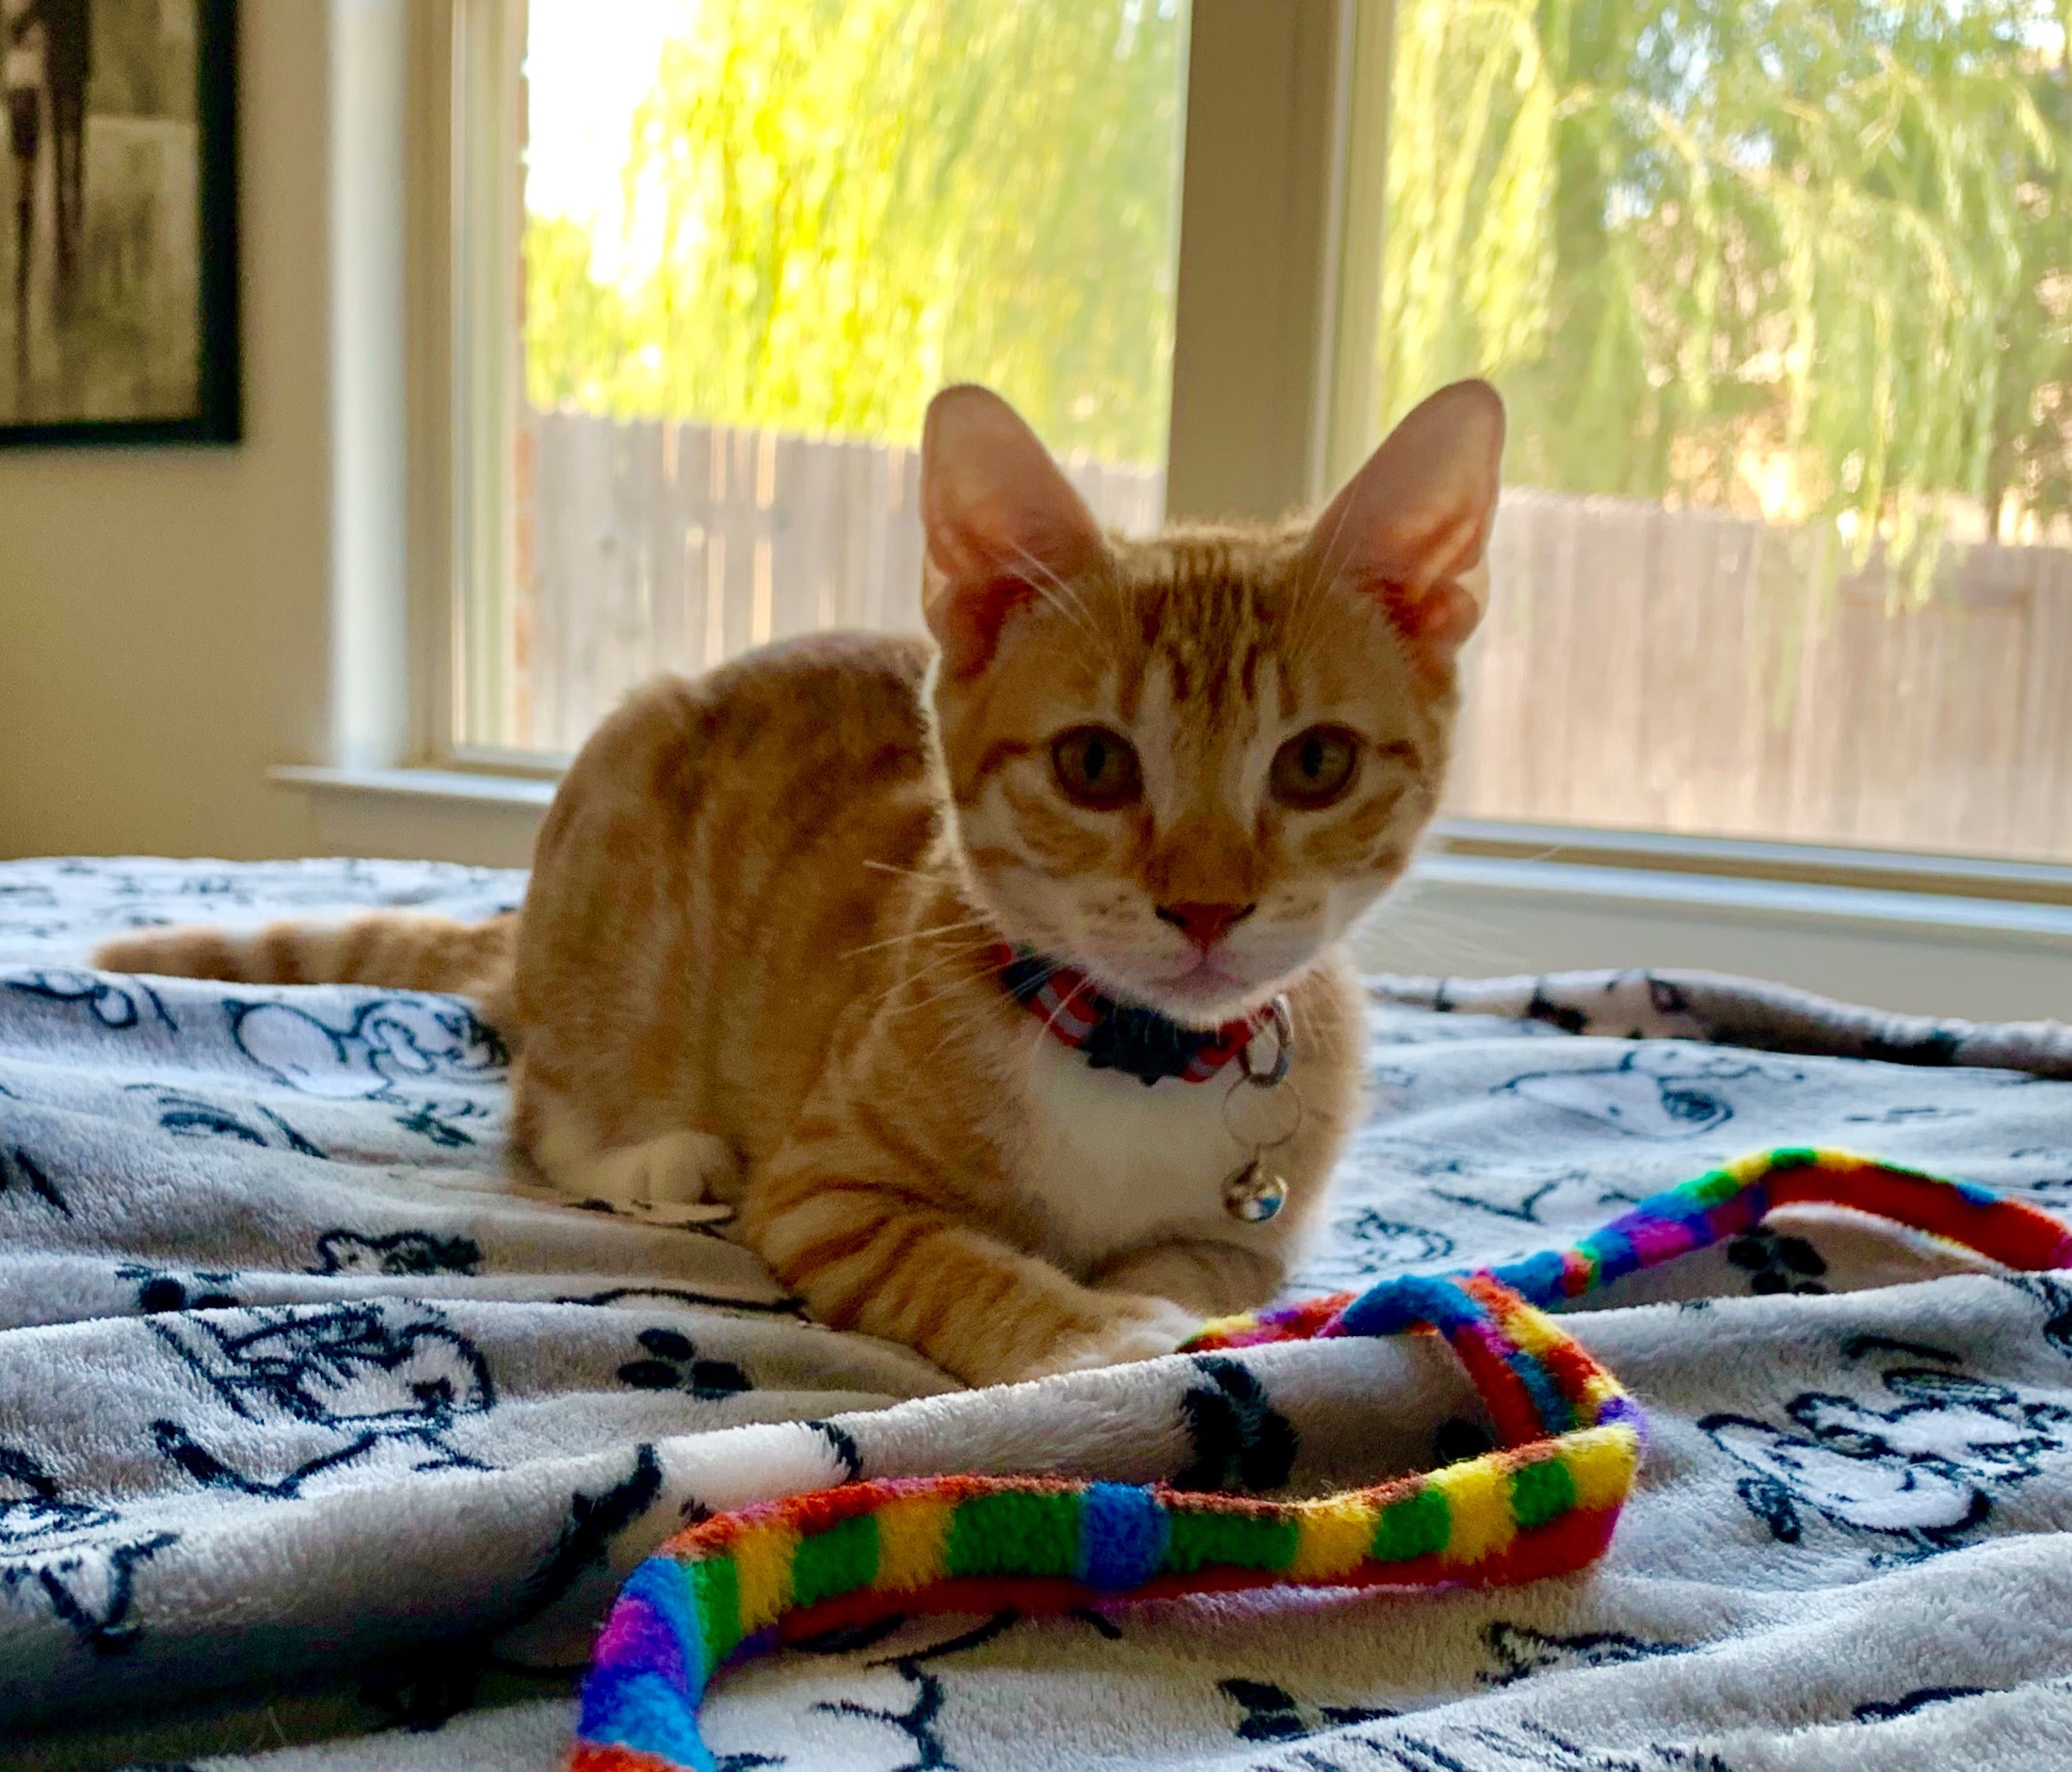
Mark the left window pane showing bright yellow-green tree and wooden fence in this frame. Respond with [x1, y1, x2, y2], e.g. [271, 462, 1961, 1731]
[489, 0, 1185, 750]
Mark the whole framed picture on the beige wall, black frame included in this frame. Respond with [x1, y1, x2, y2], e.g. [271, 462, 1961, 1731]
[0, 0, 243, 447]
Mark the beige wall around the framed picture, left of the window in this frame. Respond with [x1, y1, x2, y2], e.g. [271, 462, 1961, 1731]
[0, 0, 331, 856]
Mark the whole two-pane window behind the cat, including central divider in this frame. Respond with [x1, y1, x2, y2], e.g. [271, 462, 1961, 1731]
[435, 0, 2072, 878]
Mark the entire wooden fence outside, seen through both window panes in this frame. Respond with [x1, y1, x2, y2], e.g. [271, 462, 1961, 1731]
[507, 412, 2072, 860]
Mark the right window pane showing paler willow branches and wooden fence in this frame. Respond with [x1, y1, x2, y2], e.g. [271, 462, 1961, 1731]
[1373, 0, 2072, 858]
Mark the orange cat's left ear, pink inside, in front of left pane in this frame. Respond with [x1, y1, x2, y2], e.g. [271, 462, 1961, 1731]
[920, 385, 1109, 678]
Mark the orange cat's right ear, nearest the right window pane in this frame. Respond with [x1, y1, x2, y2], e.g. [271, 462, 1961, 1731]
[1306, 381, 1504, 671]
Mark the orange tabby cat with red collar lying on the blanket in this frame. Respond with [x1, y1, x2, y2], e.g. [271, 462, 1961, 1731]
[100, 381, 1502, 1382]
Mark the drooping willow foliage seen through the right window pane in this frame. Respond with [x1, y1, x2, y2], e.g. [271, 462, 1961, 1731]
[1375, 0, 2072, 554]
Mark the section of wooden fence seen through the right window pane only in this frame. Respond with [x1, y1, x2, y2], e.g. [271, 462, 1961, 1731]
[1453, 491, 2072, 858]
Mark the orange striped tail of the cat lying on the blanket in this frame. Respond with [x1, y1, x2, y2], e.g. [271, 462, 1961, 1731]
[93, 910, 518, 1020]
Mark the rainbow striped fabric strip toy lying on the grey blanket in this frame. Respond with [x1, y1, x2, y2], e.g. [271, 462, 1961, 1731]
[570, 1148, 2072, 1772]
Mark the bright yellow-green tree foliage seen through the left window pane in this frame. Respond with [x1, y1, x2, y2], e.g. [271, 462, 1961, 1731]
[524, 0, 1183, 462]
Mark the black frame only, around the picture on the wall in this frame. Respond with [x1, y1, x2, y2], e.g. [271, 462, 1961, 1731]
[0, 0, 245, 450]
